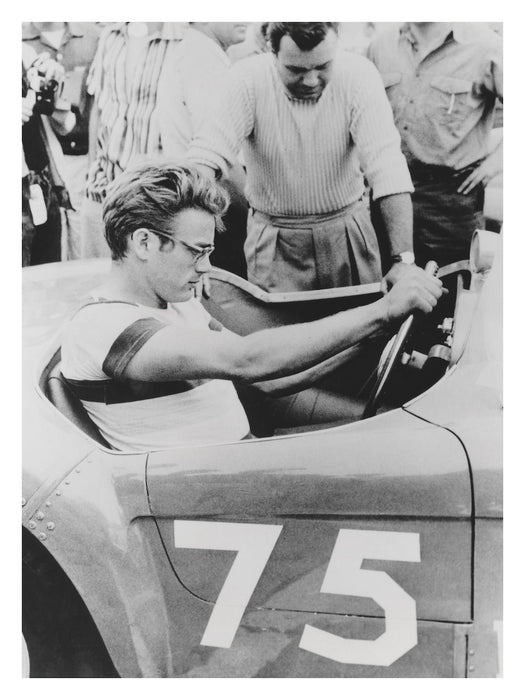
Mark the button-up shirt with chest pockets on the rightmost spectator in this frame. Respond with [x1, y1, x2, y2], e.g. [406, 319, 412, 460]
[368, 23, 503, 170]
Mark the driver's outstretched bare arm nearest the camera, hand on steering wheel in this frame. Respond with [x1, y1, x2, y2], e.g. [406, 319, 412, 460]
[124, 268, 441, 383]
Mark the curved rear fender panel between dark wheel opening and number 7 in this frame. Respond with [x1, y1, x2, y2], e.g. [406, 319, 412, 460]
[23, 451, 173, 677]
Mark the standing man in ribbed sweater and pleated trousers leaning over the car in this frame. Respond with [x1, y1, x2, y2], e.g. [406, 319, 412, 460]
[187, 22, 413, 291]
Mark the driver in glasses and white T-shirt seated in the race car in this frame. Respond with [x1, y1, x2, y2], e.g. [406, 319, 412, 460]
[58, 163, 442, 451]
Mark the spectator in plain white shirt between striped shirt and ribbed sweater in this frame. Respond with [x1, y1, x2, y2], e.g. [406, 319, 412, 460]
[157, 22, 248, 277]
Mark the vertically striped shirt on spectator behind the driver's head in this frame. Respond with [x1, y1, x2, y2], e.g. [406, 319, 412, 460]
[87, 22, 182, 201]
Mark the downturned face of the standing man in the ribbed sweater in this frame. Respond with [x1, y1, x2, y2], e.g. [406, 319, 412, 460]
[276, 29, 337, 100]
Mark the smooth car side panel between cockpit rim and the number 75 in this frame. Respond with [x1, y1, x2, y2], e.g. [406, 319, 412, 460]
[147, 409, 472, 518]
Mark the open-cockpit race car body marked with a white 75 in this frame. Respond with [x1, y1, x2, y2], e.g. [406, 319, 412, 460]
[23, 235, 502, 677]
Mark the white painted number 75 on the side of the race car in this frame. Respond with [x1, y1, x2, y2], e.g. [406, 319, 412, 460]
[174, 520, 421, 666]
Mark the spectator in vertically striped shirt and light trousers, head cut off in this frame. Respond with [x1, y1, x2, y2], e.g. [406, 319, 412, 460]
[81, 22, 185, 258]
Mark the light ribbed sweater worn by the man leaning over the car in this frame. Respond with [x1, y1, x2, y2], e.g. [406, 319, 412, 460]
[187, 52, 412, 216]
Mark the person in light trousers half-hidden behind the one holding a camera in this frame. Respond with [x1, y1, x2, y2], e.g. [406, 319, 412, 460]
[22, 22, 100, 260]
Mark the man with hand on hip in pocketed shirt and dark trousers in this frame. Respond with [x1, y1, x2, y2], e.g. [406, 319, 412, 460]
[368, 22, 503, 266]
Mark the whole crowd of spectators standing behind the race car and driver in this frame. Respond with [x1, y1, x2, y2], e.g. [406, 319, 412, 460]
[22, 22, 503, 290]
